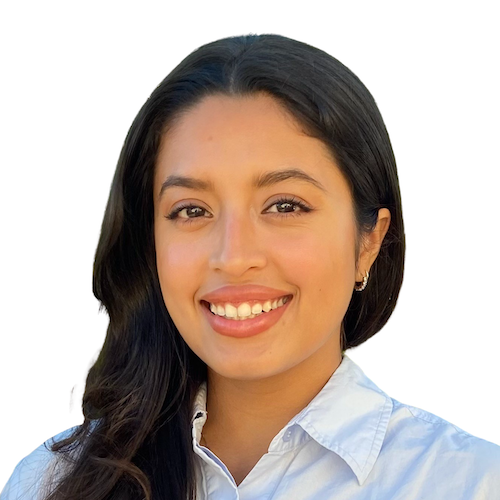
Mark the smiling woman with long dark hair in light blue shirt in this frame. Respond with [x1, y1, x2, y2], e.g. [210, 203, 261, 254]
[1, 35, 500, 500]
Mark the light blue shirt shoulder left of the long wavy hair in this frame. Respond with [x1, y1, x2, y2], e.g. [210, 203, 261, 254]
[0, 426, 79, 500]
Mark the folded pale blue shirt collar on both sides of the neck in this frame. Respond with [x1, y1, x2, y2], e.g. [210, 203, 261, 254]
[189, 354, 392, 485]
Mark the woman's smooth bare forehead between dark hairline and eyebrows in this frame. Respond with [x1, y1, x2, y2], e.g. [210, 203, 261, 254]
[155, 93, 345, 202]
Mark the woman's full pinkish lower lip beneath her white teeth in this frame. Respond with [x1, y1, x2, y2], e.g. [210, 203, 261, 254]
[201, 297, 292, 338]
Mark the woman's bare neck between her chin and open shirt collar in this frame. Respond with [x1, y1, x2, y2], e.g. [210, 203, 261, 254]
[203, 340, 342, 455]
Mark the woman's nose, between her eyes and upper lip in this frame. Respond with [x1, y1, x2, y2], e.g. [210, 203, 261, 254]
[209, 208, 266, 277]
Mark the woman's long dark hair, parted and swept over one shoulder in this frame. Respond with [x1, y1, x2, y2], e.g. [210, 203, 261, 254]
[46, 35, 405, 500]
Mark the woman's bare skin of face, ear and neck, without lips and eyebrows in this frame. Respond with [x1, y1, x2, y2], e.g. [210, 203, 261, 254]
[154, 93, 390, 484]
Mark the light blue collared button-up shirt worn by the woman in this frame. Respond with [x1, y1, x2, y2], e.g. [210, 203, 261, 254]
[0, 355, 500, 500]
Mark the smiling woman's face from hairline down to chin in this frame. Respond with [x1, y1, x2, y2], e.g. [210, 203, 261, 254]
[154, 94, 363, 380]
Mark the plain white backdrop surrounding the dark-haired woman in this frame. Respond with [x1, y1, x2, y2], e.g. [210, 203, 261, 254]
[0, 0, 500, 488]
